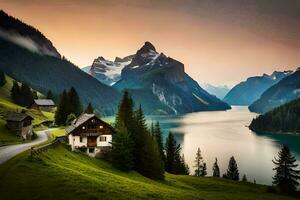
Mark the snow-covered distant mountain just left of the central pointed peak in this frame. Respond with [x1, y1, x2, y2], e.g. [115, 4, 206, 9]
[83, 55, 133, 85]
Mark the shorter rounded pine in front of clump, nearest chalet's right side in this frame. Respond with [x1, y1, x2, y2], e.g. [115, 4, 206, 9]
[111, 127, 134, 171]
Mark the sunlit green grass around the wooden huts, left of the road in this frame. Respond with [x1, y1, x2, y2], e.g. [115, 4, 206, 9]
[0, 76, 54, 145]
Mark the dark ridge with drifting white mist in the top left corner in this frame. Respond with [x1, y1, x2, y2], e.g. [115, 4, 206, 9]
[0, 10, 61, 58]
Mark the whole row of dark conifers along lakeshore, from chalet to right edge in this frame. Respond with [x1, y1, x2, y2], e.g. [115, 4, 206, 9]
[111, 91, 300, 195]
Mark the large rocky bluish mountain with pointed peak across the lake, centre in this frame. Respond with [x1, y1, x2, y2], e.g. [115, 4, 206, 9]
[113, 42, 230, 114]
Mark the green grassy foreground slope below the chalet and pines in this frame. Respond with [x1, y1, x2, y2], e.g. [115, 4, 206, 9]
[0, 146, 292, 200]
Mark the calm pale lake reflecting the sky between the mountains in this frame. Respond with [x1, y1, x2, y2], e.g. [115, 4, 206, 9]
[147, 106, 300, 185]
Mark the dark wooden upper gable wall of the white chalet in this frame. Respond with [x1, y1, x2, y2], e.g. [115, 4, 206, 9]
[72, 117, 113, 135]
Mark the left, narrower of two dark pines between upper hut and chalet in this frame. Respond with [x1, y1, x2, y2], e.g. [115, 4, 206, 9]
[55, 90, 69, 125]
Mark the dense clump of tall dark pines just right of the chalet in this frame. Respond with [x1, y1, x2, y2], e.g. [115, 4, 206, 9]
[111, 91, 189, 179]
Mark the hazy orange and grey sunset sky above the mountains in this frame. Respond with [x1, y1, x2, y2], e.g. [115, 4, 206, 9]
[0, 0, 300, 86]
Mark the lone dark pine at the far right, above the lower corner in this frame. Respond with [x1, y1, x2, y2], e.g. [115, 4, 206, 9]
[273, 145, 300, 192]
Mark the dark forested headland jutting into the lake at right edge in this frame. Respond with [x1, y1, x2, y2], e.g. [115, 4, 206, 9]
[249, 99, 300, 133]
